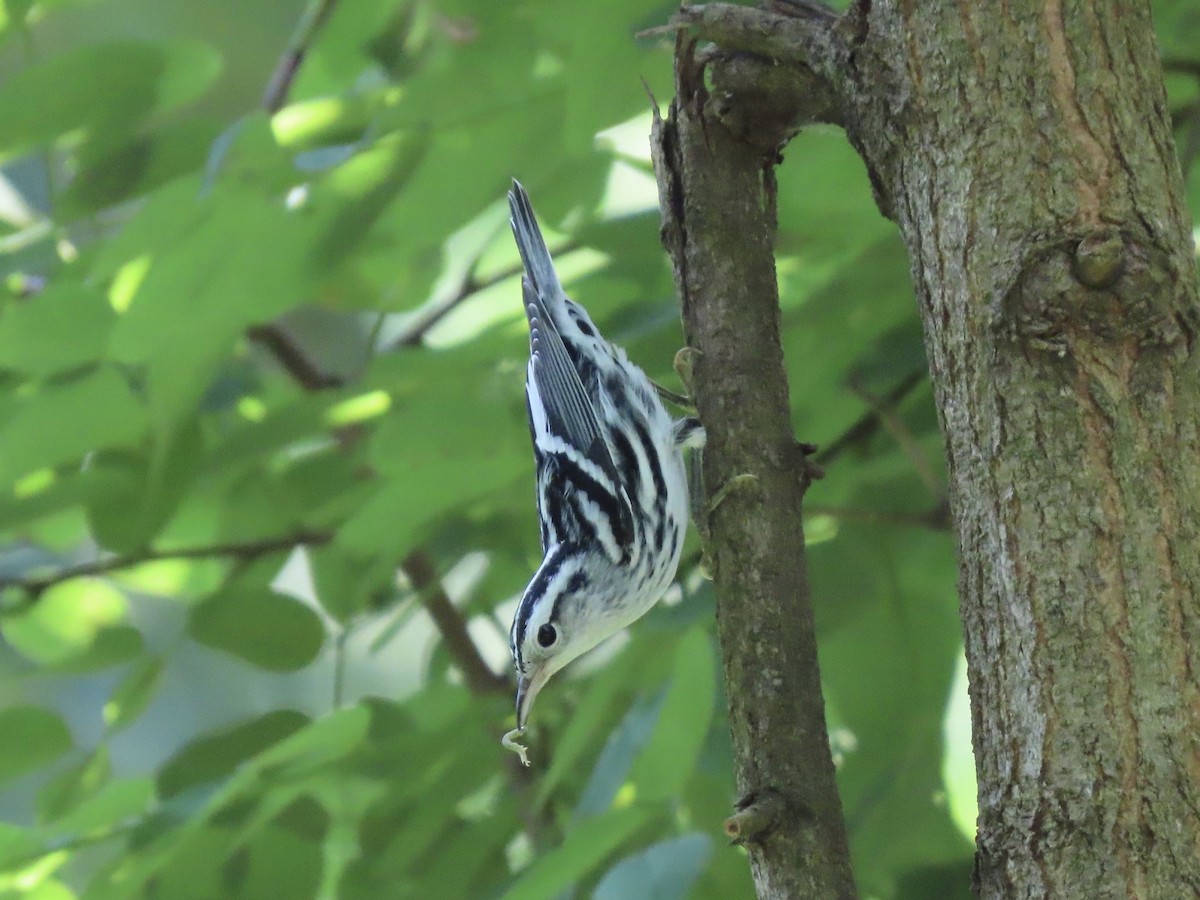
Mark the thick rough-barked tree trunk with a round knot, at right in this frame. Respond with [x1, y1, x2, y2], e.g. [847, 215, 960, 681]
[680, 0, 1200, 898]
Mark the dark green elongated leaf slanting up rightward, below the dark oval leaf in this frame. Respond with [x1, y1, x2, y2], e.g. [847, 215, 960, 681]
[157, 709, 308, 798]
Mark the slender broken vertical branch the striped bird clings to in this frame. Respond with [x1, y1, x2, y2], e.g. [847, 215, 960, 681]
[653, 35, 854, 900]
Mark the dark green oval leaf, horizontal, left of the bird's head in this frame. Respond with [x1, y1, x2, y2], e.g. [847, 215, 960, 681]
[187, 583, 325, 672]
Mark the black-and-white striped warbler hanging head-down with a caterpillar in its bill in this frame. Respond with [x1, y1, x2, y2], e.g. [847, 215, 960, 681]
[504, 181, 703, 764]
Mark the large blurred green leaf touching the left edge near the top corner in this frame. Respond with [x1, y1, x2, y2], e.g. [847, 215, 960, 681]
[0, 40, 221, 160]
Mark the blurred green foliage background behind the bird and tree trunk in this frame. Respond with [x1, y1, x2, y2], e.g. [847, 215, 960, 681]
[0, 0, 1200, 900]
